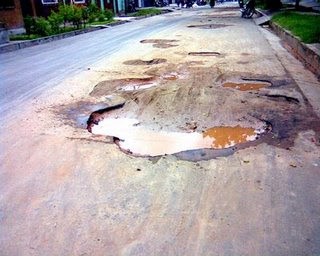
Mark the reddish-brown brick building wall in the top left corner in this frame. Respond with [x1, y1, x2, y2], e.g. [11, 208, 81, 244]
[0, 0, 24, 29]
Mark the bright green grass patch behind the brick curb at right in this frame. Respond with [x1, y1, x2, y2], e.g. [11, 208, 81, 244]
[272, 11, 320, 44]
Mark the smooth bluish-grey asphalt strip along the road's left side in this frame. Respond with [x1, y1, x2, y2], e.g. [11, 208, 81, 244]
[0, 11, 186, 118]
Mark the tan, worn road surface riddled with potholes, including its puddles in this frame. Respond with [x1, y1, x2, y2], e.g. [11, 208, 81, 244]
[0, 5, 320, 255]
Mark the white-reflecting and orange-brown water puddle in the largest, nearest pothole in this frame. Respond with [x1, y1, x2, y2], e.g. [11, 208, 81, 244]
[91, 118, 265, 156]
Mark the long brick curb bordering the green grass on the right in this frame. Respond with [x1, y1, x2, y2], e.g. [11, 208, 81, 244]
[269, 21, 320, 79]
